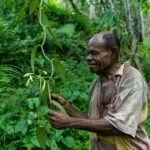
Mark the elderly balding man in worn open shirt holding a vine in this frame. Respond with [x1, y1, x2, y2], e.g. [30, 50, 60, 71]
[49, 32, 150, 150]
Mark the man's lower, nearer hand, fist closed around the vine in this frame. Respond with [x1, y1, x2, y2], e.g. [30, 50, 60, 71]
[48, 111, 71, 129]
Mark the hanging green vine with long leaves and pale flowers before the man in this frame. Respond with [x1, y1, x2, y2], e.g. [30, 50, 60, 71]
[24, 0, 67, 150]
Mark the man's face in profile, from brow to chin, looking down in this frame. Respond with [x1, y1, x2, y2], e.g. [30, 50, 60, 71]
[87, 44, 112, 74]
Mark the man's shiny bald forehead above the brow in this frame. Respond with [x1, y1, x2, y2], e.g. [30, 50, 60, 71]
[88, 34, 106, 46]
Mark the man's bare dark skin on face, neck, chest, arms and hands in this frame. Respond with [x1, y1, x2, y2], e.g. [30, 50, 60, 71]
[48, 32, 125, 136]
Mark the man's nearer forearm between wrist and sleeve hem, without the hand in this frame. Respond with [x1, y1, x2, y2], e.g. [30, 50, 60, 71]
[68, 118, 125, 136]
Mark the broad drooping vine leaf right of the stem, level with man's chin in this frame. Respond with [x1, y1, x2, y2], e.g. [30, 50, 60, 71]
[52, 59, 65, 81]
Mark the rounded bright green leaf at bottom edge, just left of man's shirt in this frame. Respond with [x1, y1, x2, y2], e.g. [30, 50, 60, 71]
[61, 136, 75, 148]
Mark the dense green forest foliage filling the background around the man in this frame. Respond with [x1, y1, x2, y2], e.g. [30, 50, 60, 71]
[0, 0, 150, 150]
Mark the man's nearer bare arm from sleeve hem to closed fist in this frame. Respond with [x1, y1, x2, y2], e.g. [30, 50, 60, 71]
[49, 111, 125, 136]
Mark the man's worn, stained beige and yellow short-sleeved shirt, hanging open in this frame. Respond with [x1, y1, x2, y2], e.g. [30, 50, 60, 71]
[89, 63, 150, 150]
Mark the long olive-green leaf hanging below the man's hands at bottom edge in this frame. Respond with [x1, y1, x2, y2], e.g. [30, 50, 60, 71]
[36, 127, 46, 150]
